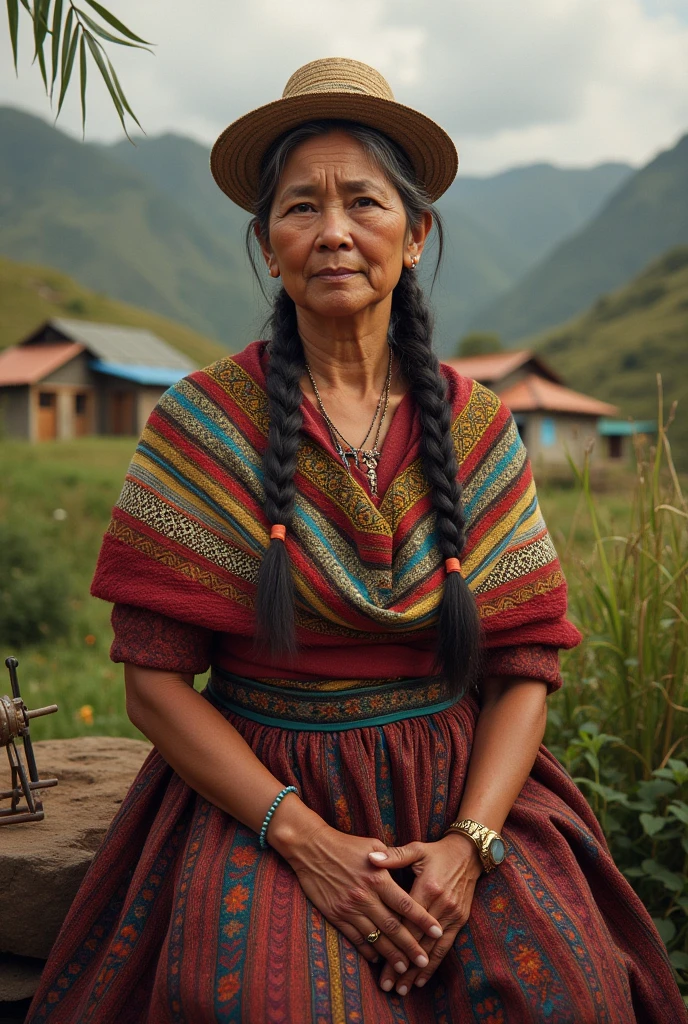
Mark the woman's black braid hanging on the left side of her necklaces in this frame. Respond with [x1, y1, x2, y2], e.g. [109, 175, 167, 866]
[256, 289, 304, 655]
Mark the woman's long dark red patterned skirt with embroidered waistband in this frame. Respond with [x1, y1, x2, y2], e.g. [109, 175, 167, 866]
[28, 674, 688, 1024]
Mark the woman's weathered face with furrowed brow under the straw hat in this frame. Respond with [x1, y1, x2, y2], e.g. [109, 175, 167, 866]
[261, 131, 432, 316]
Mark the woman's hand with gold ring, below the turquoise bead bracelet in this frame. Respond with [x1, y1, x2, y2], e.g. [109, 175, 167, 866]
[269, 801, 442, 970]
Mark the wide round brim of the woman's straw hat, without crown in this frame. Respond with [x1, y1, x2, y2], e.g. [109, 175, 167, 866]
[210, 92, 459, 213]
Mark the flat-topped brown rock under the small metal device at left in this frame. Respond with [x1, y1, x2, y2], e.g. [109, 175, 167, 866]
[0, 736, 151, 958]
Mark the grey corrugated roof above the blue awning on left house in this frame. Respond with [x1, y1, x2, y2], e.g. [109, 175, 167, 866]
[41, 316, 196, 373]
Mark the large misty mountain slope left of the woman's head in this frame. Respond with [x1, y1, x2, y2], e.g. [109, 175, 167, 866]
[0, 109, 262, 350]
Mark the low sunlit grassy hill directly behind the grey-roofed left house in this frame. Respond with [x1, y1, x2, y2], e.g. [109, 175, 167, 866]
[0, 256, 227, 367]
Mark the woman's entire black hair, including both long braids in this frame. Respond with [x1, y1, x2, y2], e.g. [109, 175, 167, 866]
[246, 121, 480, 695]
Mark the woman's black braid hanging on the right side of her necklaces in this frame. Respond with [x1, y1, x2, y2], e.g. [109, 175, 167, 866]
[391, 269, 481, 695]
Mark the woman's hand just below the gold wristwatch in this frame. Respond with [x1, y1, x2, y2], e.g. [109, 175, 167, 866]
[369, 834, 482, 995]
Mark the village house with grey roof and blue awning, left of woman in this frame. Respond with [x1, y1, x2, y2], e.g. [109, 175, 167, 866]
[0, 318, 196, 441]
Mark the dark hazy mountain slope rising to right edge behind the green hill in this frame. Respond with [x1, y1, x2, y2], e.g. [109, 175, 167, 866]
[472, 135, 688, 340]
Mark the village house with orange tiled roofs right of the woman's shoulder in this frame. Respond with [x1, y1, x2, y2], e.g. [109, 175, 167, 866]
[447, 349, 634, 469]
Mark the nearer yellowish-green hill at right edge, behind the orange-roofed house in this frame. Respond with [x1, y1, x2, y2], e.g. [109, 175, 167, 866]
[528, 246, 688, 467]
